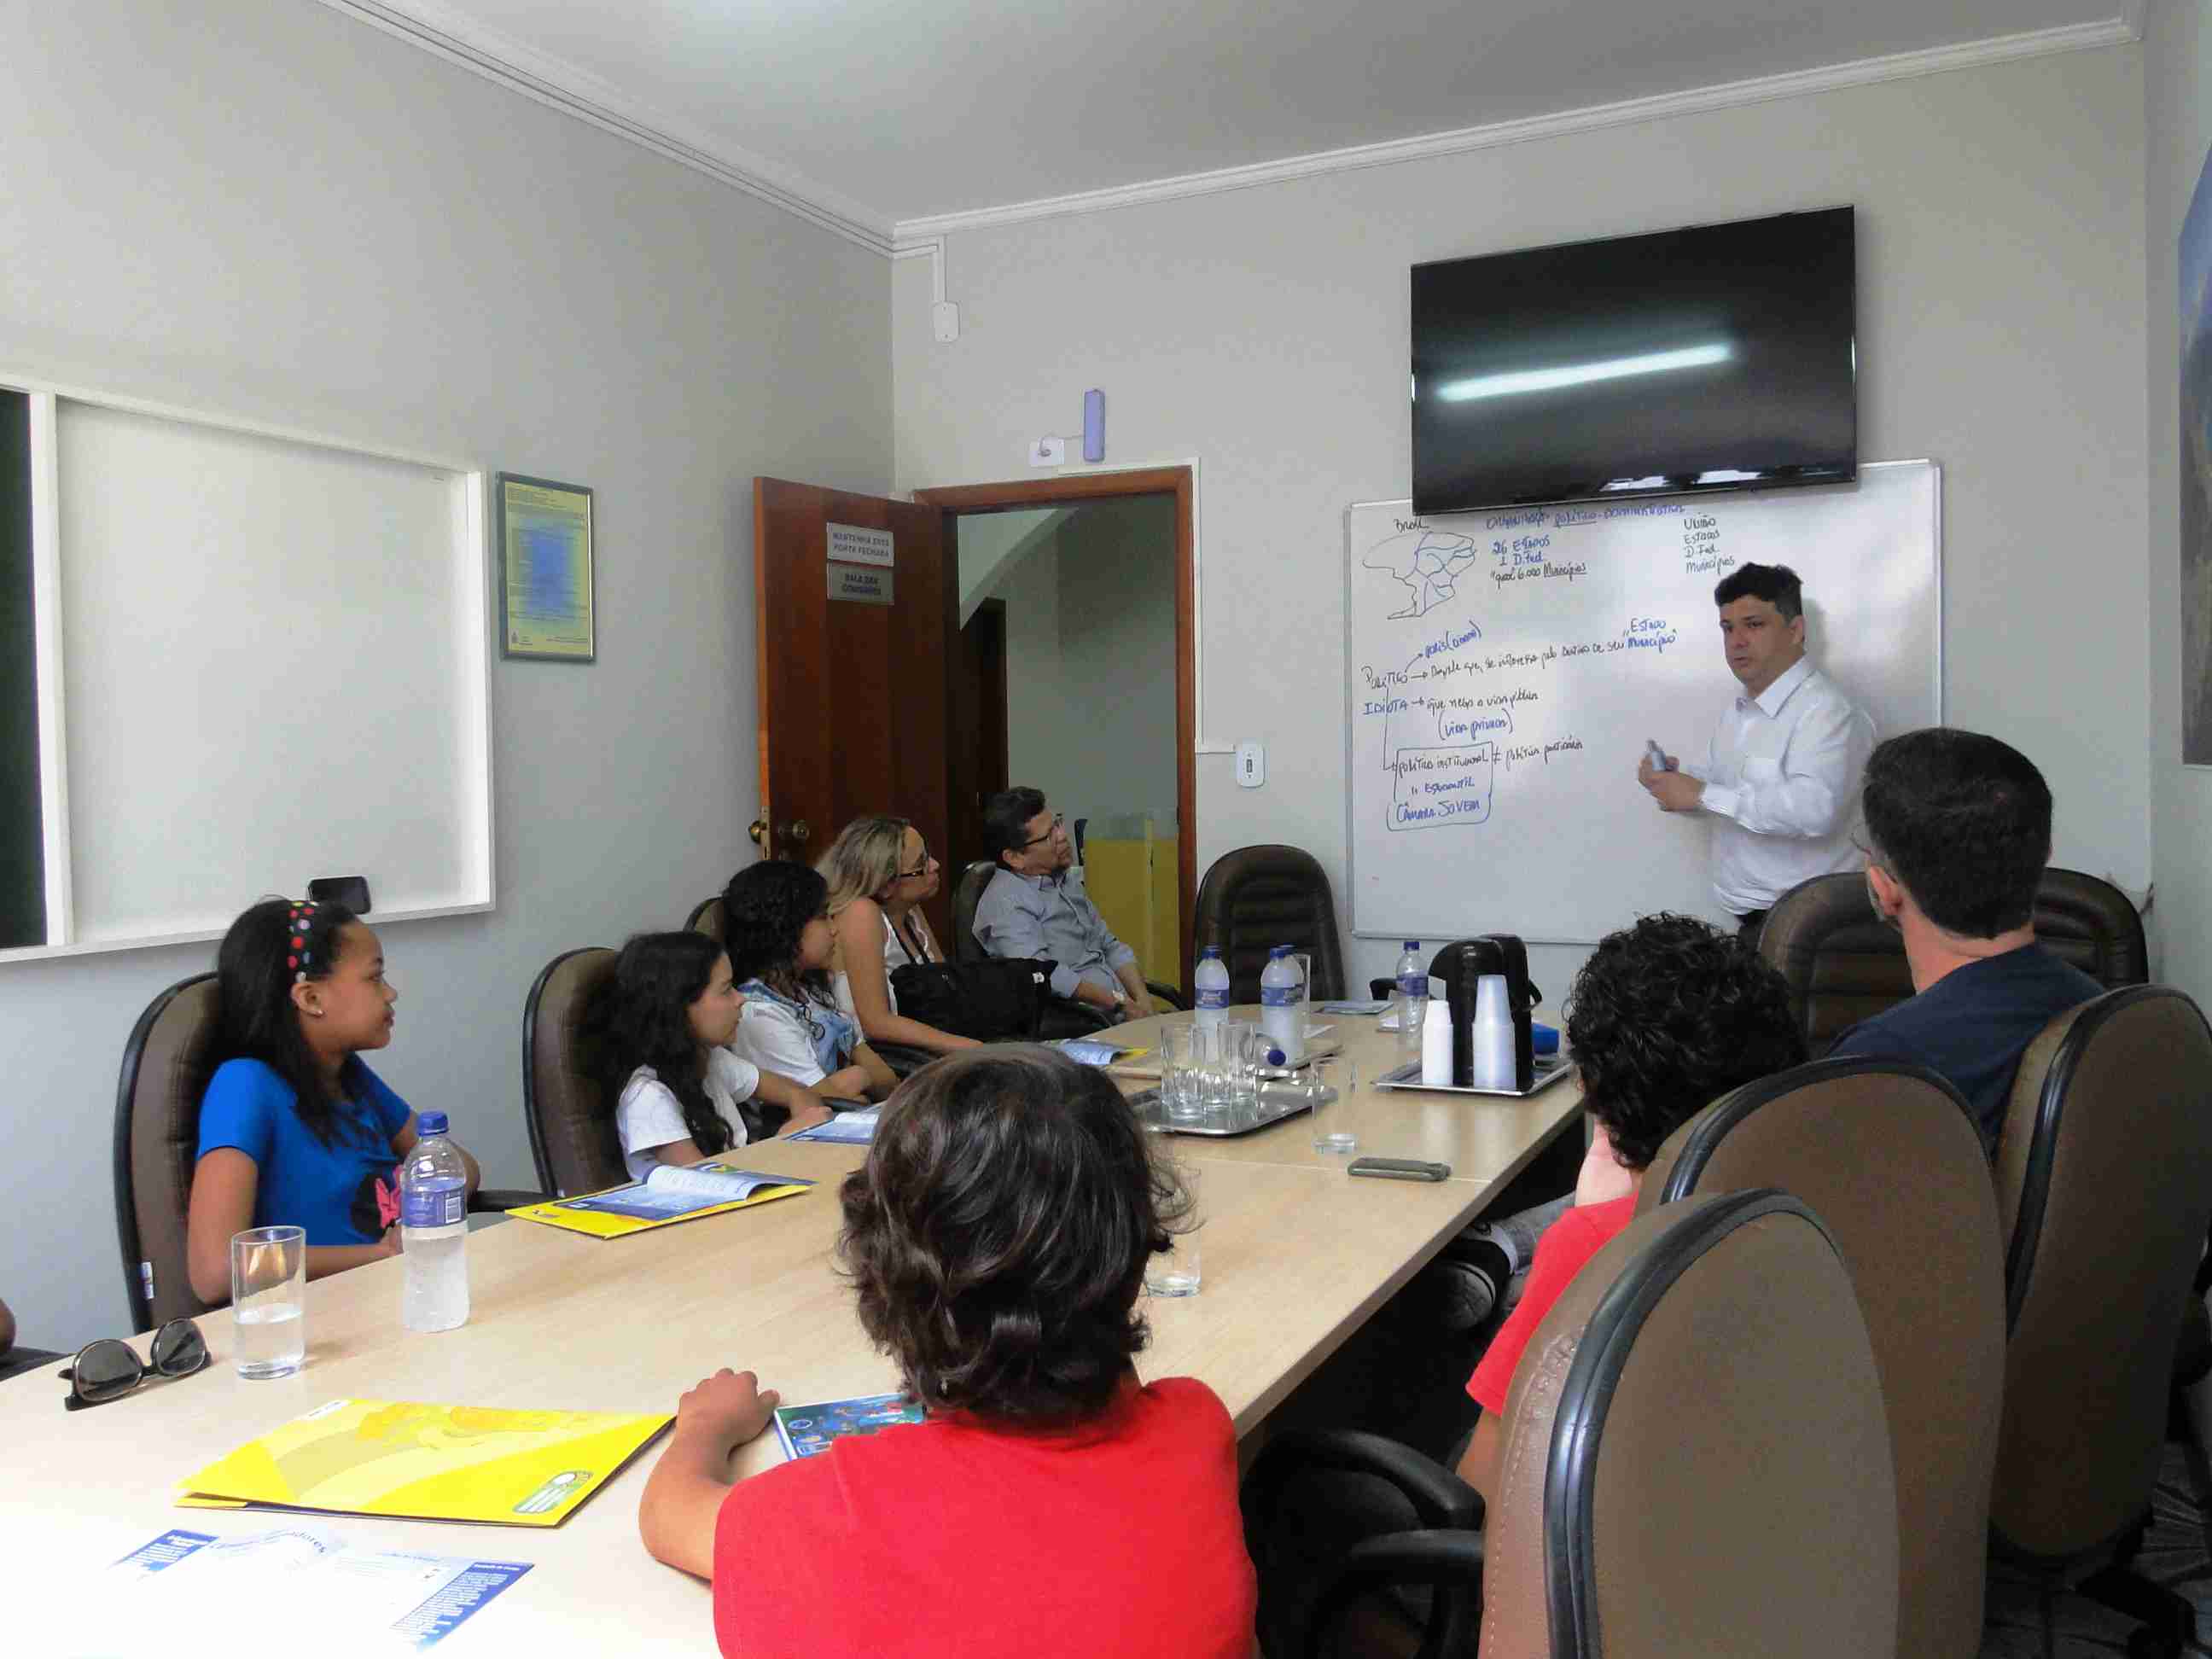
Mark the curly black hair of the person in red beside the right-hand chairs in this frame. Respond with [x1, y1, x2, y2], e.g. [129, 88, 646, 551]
[1566, 911, 1805, 1170]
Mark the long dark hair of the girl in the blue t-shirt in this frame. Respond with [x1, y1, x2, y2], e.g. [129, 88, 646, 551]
[197, 898, 385, 1148]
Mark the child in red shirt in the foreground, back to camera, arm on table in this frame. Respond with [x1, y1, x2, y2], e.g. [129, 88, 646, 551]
[637, 1046, 1256, 1659]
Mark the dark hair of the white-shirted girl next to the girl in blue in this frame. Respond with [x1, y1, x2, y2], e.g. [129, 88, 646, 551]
[582, 931, 736, 1157]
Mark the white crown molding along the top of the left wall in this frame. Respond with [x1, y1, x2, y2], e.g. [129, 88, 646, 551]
[318, 0, 892, 254]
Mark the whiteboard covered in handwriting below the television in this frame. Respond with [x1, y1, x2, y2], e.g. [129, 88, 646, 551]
[1345, 460, 1942, 945]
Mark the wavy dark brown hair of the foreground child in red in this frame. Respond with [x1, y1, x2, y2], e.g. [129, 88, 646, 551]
[838, 1044, 1190, 1427]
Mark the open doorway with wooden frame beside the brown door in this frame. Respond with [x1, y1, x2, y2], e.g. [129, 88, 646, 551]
[913, 467, 1196, 993]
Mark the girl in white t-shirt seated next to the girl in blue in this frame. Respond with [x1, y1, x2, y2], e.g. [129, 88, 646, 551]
[591, 934, 830, 1181]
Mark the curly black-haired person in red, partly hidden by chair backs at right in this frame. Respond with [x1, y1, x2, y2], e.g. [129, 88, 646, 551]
[1460, 913, 1805, 1502]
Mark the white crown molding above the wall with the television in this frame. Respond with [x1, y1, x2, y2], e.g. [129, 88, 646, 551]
[894, 15, 2145, 246]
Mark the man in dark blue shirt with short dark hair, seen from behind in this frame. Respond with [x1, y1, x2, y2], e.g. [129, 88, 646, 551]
[1831, 725, 2104, 1157]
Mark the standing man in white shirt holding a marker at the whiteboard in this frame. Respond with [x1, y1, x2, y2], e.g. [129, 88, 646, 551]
[1637, 564, 1873, 940]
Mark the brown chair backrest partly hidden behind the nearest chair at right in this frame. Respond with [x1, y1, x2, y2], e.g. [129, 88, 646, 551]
[1637, 1060, 2004, 1659]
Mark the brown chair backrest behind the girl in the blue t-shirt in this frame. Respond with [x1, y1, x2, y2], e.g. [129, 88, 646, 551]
[115, 973, 217, 1331]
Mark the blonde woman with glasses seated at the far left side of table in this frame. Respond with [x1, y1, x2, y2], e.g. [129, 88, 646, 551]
[814, 816, 978, 1055]
